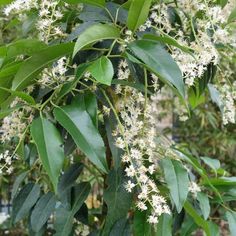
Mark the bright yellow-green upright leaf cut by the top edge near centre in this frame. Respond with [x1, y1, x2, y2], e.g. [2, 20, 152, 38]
[127, 0, 152, 31]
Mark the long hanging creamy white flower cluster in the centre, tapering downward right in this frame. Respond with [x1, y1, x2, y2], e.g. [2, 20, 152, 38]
[113, 83, 183, 223]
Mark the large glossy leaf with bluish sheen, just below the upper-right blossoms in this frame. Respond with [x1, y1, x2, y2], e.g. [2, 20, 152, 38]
[128, 40, 185, 98]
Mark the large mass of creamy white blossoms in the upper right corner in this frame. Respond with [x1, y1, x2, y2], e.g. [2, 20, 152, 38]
[139, 0, 235, 87]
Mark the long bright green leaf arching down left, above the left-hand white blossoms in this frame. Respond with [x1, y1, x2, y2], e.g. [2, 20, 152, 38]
[12, 43, 74, 90]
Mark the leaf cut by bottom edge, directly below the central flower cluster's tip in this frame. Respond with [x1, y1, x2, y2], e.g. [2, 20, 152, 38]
[156, 214, 172, 236]
